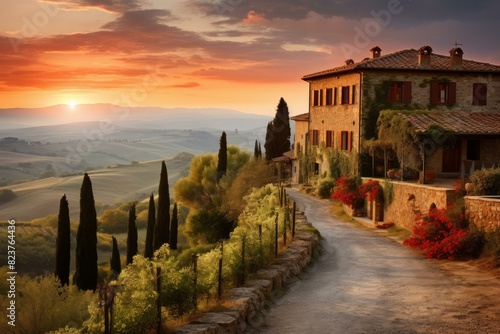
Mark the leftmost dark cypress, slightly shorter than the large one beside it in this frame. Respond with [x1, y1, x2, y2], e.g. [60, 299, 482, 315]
[55, 195, 71, 285]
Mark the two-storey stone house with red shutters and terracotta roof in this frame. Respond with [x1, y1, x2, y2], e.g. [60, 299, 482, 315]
[292, 46, 500, 182]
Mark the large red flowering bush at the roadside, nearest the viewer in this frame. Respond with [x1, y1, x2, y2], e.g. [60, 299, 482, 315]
[403, 208, 483, 260]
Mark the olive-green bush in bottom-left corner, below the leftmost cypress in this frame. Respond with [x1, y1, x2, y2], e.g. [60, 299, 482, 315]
[0, 274, 93, 334]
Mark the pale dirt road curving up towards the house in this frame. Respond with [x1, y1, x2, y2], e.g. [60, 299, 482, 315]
[254, 190, 500, 334]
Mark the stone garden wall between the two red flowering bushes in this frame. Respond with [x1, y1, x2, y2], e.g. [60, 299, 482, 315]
[381, 181, 455, 229]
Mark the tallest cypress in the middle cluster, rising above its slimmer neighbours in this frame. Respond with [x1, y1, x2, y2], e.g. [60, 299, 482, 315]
[153, 161, 170, 251]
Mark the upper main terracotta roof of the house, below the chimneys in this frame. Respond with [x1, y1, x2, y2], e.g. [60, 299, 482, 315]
[302, 49, 500, 80]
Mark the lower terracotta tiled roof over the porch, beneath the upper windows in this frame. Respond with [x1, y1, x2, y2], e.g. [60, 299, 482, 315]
[401, 111, 500, 135]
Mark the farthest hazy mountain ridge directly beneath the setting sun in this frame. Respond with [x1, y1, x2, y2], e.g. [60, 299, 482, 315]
[0, 104, 272, 132]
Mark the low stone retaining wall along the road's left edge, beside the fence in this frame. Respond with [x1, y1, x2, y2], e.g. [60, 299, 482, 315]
[173, 212, 319, 334]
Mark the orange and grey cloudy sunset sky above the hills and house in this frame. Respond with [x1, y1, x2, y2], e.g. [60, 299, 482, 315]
[0, 0, 500, 116]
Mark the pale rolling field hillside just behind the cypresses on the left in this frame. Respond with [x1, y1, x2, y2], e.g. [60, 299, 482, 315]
[0, 153, 193, 221]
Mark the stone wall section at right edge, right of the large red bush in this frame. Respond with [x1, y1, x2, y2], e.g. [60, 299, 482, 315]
[465, 196, 500, 233]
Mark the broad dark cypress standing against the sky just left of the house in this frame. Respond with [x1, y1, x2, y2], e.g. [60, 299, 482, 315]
[264, 98, 291, 160]
